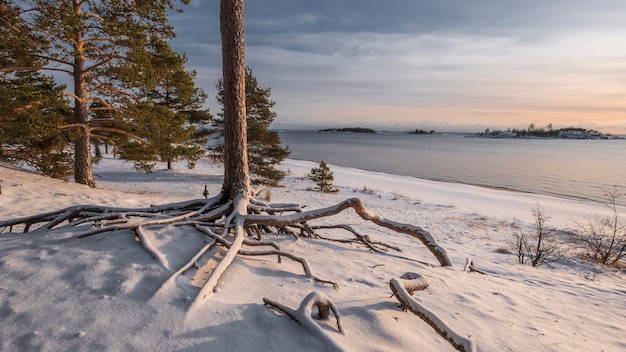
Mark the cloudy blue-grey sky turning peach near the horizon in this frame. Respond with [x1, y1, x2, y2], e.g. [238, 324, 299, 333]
[166, 0, 626, 133]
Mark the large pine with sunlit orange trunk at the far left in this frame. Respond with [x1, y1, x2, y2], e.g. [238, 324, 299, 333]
[0, 0, 189, 187]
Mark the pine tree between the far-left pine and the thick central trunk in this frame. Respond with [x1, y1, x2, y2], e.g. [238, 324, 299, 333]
[122, 41, 211, 171]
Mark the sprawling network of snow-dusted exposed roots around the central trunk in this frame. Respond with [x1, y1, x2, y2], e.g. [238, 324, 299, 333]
[0, 195, 454, 344]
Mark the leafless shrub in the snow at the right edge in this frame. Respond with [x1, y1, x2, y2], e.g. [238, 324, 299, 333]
[572, 186, 626, 265]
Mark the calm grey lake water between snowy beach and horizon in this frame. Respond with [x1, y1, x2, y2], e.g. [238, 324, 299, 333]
[280, 131, 626, 205]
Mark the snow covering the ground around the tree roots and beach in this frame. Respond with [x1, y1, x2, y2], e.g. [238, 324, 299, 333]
[0, 156, 626, 352]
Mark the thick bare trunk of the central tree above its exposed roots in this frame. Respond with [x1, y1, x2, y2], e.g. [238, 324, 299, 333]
[220, 0, 251, 199]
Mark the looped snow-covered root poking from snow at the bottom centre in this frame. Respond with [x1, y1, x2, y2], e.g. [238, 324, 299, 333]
[263, 292, 345, 351]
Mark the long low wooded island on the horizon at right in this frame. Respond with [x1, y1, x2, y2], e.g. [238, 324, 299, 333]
[468, 124, 620, 139]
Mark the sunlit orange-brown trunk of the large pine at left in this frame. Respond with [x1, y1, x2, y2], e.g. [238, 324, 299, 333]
[74, 25, 96, 188]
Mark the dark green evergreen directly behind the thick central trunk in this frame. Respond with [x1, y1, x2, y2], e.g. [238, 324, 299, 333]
[210, 68, 290, 185]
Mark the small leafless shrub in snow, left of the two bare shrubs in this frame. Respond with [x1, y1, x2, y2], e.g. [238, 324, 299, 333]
[511, 203, 563, 267]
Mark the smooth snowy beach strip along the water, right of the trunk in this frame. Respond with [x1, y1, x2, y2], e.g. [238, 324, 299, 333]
[281, 159, 626, 226]
